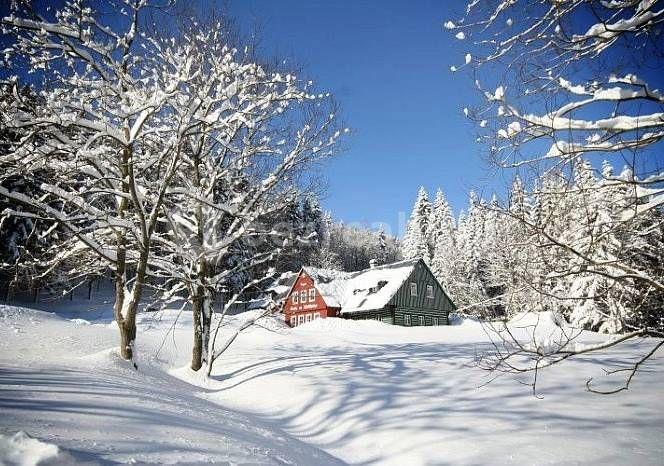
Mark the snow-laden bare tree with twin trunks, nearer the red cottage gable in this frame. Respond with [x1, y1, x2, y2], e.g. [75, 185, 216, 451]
[139, 25, 342, 372]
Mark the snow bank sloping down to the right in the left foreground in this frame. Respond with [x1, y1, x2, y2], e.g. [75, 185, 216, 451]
[0, 306, 339, 464]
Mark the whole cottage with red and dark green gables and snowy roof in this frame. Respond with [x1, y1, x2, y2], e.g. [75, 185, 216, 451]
[283, 259, 456, 326]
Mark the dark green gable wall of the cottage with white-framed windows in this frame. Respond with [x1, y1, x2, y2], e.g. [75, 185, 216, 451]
[388, 262, 456, 326]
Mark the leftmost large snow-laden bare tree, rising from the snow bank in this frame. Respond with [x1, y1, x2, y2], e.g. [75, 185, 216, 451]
[0, 0, 196, 359]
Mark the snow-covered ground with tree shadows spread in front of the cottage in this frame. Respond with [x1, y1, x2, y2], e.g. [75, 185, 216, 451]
[0, 296, 664, 465]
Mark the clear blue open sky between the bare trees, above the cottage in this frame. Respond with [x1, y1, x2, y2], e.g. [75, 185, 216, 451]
[229, 0, 482, 233]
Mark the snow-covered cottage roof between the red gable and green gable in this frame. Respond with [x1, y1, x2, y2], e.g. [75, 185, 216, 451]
[303, 259, 419, 314]
